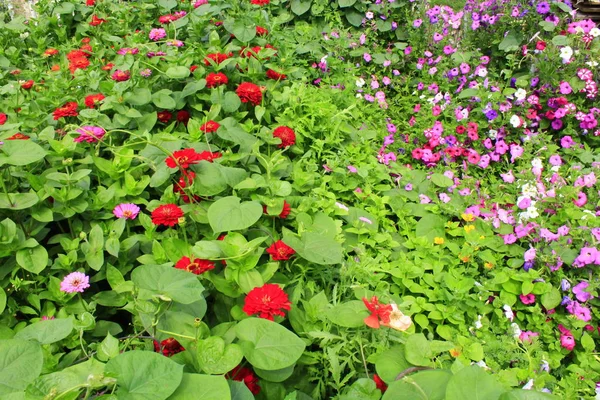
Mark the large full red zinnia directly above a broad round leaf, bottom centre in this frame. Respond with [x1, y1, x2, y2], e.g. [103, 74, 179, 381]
[242, 283, 291, 321]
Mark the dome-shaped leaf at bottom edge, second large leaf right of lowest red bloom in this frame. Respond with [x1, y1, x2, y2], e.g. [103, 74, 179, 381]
[446, 365, 505, 400]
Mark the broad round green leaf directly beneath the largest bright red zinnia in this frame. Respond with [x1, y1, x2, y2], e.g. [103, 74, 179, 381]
[235, 318, 305, 371]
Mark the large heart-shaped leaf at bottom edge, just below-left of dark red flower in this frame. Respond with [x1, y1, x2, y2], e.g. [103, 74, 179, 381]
[105, 350, 183, 400]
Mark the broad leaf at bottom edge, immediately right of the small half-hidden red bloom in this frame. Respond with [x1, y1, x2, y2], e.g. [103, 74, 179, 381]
[382, 370, 450, 400]
